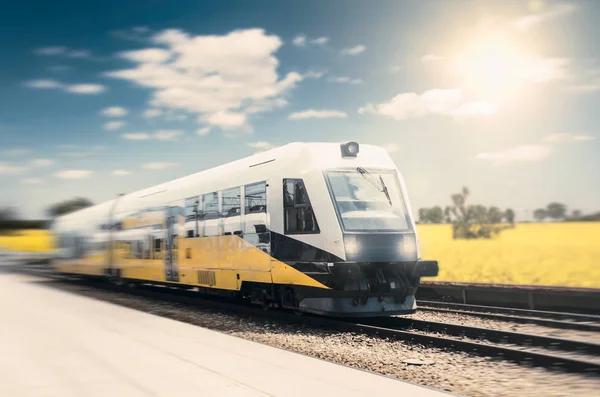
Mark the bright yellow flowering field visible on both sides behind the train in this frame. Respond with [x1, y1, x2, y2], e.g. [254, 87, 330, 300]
[0, 222, 600, 288]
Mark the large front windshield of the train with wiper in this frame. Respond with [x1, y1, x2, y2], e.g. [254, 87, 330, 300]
[326, 167, 410, 232]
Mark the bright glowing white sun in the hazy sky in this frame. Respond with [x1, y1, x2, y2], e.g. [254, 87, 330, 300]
[457, 34, 526, 99]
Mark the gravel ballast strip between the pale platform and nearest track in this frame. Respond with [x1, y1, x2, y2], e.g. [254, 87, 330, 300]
[24, 280, 600, 397]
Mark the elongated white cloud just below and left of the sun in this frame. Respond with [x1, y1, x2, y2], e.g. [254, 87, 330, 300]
[358, 89, 496, 120]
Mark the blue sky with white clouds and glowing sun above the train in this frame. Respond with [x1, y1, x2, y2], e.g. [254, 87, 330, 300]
[0, 0, 600, 220]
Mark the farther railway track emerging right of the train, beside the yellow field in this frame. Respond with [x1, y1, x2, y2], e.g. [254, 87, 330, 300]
[417, 301, 600, 332]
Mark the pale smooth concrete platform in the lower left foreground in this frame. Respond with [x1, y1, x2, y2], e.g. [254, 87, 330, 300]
[0, 272, 447, 397]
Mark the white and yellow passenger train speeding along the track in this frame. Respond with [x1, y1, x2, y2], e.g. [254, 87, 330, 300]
[51, 142, 438, 317]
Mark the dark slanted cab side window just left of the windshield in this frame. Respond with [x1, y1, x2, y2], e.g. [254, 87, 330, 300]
[283, 179, 320, 234]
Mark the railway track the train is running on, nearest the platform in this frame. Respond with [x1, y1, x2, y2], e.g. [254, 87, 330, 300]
[5, 262, 600, 374]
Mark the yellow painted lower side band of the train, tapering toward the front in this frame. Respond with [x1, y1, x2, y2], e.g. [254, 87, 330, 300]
[54, 236, 330, 291]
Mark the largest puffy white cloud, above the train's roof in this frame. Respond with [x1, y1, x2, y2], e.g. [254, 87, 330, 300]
[107, 29, 302, 129]
